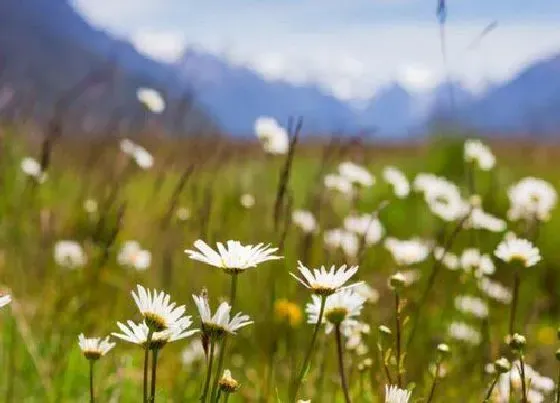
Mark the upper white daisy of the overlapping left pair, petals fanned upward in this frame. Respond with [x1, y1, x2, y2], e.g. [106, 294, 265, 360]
[131, 285, 185, 332]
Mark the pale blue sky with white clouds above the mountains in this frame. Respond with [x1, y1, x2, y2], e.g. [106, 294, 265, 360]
[74, 0, 560, 100]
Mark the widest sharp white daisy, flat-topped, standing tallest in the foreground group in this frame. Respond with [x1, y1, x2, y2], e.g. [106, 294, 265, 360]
[185, 239, 282, 274]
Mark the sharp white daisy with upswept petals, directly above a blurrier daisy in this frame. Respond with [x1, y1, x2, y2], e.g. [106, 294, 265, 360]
[290, 260, 358, 296]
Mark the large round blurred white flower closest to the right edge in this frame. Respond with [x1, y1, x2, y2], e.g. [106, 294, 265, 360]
[508, 177, 558, 221]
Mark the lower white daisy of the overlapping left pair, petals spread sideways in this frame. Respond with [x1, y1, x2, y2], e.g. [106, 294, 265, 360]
[112, 316, 200, 350]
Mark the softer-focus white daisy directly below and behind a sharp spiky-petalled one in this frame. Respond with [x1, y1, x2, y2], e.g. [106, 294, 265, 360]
[305, 289, 365, 333]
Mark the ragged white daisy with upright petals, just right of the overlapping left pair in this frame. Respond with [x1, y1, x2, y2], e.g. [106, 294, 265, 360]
[193, 293, 253, 337]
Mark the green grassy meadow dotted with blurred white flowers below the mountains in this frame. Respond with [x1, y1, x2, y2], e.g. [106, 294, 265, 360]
[0, 120, 560, 403]
